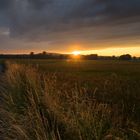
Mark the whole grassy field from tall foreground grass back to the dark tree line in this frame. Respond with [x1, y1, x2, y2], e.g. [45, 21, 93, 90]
[0, 60, 140, 140]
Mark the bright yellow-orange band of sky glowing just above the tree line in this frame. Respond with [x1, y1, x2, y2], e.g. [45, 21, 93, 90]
[0, 45, 140, 57]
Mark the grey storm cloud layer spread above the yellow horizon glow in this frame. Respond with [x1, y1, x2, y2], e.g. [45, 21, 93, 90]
[0, 0, 140, 53]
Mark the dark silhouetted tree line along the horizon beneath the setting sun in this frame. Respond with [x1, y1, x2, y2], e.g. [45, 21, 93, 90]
[0, 51, 140, 60]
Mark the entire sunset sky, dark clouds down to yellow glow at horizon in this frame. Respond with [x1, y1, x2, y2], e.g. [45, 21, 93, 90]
[0, 0, 140, 56]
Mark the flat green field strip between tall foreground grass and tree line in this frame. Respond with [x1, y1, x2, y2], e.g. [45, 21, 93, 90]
[14, 60, 140, 76]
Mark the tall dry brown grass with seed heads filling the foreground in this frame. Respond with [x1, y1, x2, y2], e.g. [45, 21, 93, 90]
[0, 63, 140, 140]
